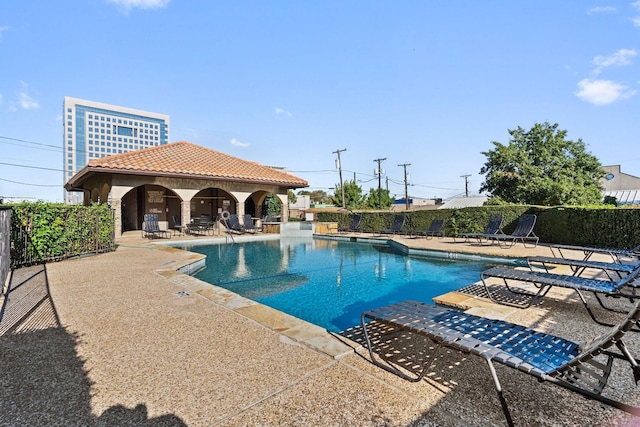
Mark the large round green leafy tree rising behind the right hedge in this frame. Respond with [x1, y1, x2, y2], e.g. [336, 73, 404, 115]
[480, 122, 604, 206]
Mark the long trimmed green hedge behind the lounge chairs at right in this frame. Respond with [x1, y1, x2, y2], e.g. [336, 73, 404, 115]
[318, 205, 640, 248]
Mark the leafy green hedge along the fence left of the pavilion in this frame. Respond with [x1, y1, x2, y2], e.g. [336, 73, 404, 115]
[6, 202, 115, 267]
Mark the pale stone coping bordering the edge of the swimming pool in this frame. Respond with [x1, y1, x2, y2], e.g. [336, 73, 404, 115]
[152, 234, 521, 359]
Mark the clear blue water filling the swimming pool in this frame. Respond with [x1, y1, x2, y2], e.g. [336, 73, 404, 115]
[183, 238, 504, 332]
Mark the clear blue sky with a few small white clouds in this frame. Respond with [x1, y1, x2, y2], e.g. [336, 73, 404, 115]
[0, 0, 640, 201]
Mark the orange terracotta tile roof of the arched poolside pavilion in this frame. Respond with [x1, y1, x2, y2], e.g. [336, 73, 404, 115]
[79, 141, 308, 188]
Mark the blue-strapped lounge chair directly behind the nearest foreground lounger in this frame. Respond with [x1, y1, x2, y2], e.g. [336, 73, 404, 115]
[480, 267, 640, 326]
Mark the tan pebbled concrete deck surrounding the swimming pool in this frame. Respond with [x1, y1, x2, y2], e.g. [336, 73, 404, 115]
[0, 232, 640, 426]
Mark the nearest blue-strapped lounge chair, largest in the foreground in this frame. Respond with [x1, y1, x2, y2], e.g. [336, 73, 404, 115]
[361, 301, 640, 426]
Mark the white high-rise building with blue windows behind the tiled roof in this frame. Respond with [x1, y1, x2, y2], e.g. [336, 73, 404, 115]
[62, 96, 169, 203]
